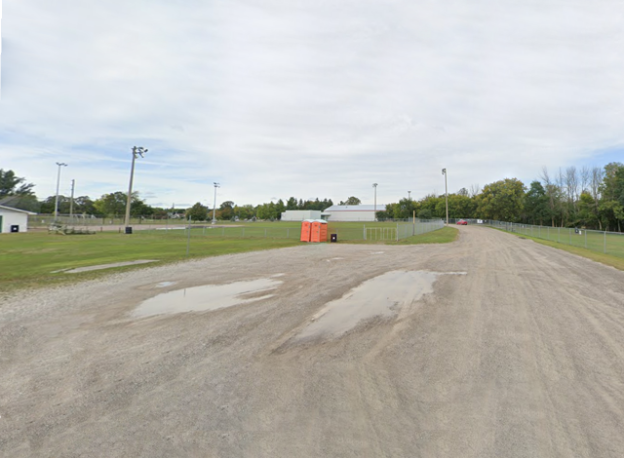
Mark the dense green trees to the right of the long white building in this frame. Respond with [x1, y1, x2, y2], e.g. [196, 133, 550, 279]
[377, 162, 624, 232]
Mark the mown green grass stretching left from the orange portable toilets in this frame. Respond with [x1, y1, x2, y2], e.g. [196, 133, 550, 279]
[0, 231, 300, 291]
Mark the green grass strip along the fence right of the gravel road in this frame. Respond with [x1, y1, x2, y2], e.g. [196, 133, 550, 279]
[494, 227, 624, 270]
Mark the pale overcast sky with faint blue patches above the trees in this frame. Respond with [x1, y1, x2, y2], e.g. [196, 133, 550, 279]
[0, 0, 624, 207]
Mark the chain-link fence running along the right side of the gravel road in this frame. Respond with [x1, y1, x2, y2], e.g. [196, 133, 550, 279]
[484, 220, 624, 258]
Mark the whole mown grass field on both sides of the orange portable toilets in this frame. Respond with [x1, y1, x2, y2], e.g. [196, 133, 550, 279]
[0, 222, 457, 290]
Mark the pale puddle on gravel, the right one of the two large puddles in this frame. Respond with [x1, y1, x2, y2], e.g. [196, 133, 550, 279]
[296, 271, 465, 339]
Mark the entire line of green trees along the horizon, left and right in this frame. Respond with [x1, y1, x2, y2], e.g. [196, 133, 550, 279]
[0, 162, 624, 232]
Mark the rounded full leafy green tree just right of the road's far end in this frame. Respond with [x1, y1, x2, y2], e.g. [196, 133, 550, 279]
[477, 178, 524, 221]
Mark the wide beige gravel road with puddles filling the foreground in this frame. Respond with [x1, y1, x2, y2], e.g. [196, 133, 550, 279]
[0, 226, 624, 458]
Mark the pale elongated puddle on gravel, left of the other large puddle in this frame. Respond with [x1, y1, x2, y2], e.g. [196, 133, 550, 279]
[132, 278, 282, 317]
